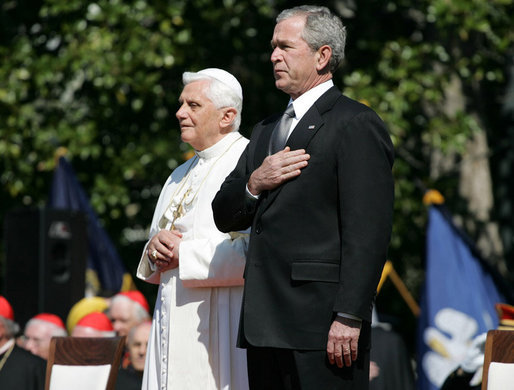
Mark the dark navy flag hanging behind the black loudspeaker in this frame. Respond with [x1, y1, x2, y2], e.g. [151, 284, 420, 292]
[47, 157, 131, 294]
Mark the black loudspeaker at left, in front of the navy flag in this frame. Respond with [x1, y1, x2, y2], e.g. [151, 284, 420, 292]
[4, 209, 88, 326]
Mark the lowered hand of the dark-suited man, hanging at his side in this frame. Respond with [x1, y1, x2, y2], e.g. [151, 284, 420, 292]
[327, 316, 361, 368]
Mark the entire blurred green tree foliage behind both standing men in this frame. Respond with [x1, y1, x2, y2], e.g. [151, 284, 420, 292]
[0, 0, 514, 336]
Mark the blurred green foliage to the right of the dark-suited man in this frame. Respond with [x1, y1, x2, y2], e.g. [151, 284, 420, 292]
[332, 0, 514, 334]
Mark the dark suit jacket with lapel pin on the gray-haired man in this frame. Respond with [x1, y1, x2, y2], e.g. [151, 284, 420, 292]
[213, 87, 394, 350]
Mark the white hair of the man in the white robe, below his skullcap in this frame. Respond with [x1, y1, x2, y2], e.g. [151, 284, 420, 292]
[182, 72, 243, 131]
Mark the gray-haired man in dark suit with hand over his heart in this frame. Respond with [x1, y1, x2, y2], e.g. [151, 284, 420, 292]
[213, 6, 394, 390]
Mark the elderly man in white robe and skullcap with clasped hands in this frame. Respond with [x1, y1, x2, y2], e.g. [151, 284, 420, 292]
[137, 68, 248, 390]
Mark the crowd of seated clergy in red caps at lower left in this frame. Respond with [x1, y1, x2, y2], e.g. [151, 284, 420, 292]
[0, 290, 152, 390]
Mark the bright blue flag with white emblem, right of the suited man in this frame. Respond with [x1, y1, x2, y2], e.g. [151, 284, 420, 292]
[417, 205, 505, 390]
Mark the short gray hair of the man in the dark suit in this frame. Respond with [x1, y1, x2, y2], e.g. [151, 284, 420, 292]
[276, 5, 346, 73]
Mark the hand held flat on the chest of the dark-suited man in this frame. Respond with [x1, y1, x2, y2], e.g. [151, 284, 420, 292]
[248, 146, 311, 195]
